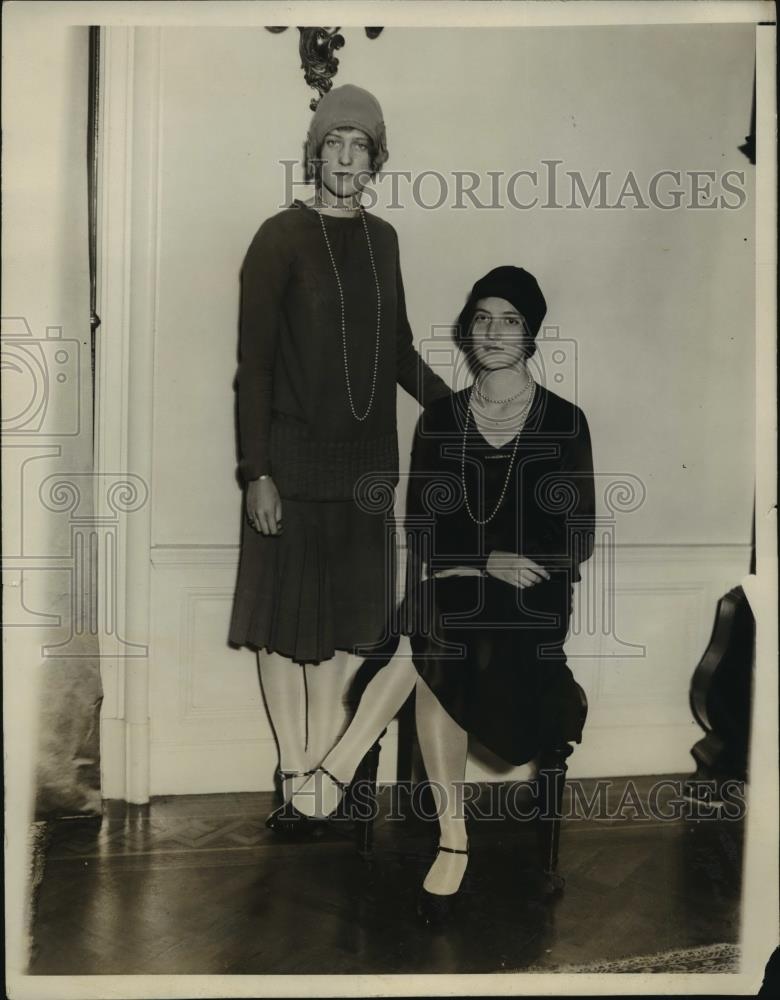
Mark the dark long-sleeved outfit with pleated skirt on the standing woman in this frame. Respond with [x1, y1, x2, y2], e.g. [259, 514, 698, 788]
[229, 202, 450, 663]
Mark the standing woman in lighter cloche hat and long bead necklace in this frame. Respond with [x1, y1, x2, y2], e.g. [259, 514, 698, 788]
[229, 85, 450, 829]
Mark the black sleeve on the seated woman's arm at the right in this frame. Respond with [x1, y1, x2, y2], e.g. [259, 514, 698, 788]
[527, 408, 596, 580]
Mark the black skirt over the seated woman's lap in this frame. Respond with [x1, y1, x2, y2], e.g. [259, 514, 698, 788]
[404, 574, 582, 764]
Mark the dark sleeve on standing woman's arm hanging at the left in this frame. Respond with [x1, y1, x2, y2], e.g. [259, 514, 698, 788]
[237, 220, 291, 483]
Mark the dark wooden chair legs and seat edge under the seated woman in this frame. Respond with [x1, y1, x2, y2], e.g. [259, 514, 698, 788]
[352, 668, 588, 893]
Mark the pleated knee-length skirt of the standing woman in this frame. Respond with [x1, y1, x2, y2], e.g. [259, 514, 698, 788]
[228, 498, 396, 663]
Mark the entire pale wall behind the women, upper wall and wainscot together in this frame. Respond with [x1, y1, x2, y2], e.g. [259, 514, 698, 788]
[96, 26, 753, 792]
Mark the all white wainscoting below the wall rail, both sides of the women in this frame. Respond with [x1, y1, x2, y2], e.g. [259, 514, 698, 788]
[146, 546, 748, 794]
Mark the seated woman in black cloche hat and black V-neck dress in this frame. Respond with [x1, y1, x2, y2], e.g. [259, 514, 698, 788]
[405, 267, 594, 923]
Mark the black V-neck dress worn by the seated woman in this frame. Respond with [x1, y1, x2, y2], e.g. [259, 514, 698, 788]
[402, 386, 594, 764]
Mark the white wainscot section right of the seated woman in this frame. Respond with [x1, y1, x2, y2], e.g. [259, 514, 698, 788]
[567, 545, 749, 777]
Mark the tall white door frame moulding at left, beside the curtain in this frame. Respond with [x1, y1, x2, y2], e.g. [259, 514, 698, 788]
[95, 27, 160, 803]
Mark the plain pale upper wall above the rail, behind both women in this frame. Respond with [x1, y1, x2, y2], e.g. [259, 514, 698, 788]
[154, 26, 754, 544]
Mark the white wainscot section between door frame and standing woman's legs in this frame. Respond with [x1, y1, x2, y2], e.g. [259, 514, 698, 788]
[150, 546, 276, 795]
